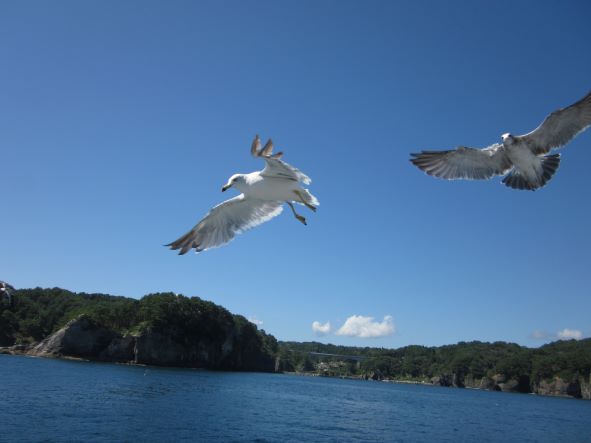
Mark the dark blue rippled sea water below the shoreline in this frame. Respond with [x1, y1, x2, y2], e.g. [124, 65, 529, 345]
[0, 355, 591, 442]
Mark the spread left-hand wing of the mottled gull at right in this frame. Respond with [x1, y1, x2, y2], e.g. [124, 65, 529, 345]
[410, 144, 512, 180]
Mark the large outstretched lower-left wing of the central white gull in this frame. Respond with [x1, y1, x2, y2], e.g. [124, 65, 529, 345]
[166, 194, 283, 255]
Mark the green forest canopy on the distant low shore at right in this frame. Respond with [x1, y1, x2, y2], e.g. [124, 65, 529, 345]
[279, 339, 591, 380]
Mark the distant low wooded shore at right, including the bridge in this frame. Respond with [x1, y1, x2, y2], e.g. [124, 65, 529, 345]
[279, 339, 591, 398]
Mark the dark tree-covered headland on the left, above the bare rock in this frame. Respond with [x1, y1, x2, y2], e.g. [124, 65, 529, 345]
[0, 288, 277, 371]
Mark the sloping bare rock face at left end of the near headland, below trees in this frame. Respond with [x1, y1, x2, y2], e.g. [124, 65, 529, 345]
[28, 315, 118, 358]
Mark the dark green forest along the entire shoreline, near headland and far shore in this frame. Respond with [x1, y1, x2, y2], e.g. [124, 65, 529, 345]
[0, 288, 591, 396]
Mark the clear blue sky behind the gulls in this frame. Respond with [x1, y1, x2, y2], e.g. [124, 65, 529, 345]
[0, 1, 591, 347]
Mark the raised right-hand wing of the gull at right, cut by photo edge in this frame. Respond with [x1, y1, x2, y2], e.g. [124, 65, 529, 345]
[519, 92, 591, 155]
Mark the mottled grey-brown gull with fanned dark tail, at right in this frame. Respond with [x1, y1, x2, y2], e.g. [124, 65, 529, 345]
[410, 92, 591, 191]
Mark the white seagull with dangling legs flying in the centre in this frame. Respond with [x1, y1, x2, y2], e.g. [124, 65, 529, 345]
[166, 135, 319, 254]
